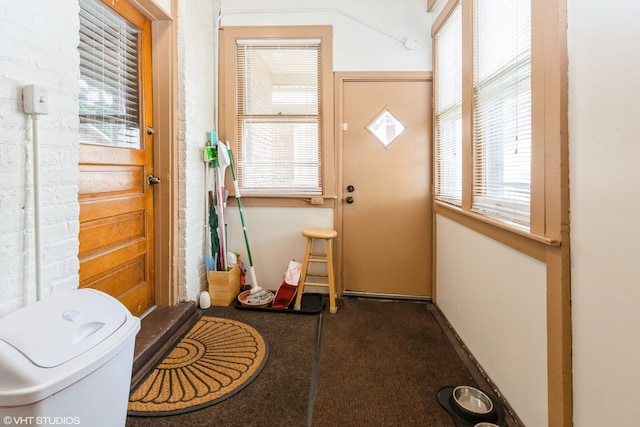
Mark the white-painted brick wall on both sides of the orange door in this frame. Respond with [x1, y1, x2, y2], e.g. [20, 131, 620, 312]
[0, 0, 220, 316]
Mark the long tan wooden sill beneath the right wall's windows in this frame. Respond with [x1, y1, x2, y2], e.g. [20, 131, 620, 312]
[434, 200, 562, 261]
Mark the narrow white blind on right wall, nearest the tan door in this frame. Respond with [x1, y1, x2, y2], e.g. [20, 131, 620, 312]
[435, 5, 462, 205]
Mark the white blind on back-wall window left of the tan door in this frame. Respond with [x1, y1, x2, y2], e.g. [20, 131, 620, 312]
[236, 40, 322, 195]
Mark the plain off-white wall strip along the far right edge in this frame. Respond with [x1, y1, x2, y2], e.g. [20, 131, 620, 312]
[568, 0, 640, 427]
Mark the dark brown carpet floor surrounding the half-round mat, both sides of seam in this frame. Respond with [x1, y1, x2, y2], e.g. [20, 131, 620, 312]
[126, 298, 516, 427]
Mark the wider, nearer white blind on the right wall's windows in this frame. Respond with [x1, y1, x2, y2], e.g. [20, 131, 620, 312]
[473, 0, 531, 228]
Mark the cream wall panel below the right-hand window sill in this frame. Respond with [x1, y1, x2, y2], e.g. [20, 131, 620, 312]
[436, 215, 547, 426]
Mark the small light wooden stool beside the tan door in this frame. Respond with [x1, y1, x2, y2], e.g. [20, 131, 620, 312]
[293, 228, 338, 313]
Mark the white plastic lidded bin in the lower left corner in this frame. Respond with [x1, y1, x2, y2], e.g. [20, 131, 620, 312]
[0, 289, 140, 427]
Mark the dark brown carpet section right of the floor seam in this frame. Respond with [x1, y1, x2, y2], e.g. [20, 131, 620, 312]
[313, 299, 474, 426]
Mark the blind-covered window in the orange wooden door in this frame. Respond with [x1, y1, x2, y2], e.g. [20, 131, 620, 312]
[78, 0, 140, 148]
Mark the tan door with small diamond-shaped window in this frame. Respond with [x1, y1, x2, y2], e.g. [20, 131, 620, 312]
[341, 79, 432, 298]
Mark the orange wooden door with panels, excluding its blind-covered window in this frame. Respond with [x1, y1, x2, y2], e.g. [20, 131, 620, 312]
[78, 2, 155, 316]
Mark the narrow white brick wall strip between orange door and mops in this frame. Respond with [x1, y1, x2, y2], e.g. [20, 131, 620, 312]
[176, 0, 219, 301]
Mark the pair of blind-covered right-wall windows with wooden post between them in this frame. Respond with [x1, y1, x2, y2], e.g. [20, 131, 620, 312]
[433, 0, 532, 230]
